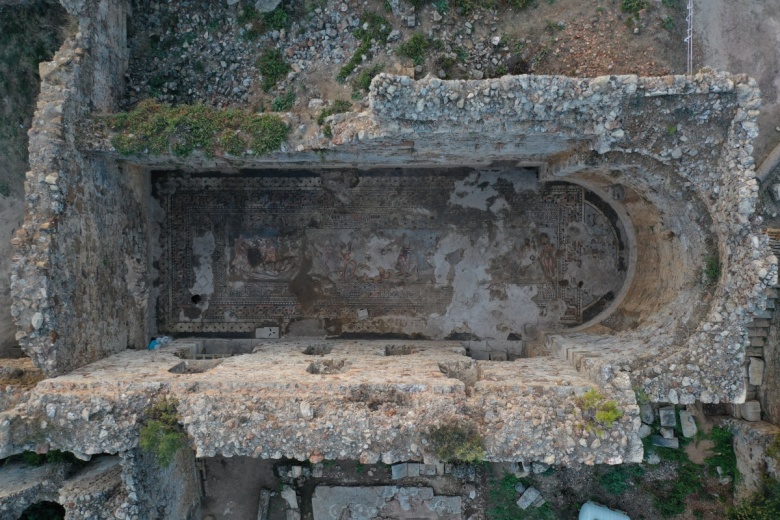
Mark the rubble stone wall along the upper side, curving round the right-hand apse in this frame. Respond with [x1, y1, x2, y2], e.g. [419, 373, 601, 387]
[82, 71, 777, 403]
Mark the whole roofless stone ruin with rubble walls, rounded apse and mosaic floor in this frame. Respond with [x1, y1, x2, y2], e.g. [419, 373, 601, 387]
[0, 0, 777, 518]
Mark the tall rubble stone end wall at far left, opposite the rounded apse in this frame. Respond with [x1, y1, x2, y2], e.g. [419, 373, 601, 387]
[11, 0, 148, 376]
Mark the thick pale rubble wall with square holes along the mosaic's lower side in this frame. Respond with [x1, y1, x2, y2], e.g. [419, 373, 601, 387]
[0, 340, 642, 465]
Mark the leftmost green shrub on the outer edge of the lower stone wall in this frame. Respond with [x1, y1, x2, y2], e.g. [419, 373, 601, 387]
[139, 397, 187, 468]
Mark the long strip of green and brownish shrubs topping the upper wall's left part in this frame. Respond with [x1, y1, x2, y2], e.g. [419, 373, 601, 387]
[107, 100, 289, 157]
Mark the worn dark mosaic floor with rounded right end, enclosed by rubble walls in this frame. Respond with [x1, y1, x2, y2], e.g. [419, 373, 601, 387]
[153, 168, 627, 340]
